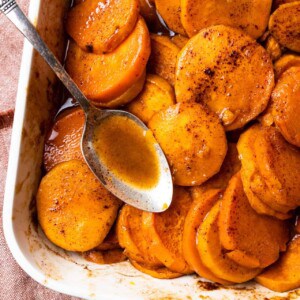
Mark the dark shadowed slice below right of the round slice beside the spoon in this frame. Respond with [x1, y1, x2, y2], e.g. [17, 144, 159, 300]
[197, 143, 241, 191]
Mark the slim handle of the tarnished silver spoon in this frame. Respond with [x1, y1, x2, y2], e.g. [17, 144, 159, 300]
[0, 0, 90, 111]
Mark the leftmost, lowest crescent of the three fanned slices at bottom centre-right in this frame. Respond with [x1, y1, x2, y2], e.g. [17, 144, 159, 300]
[183, 187, 229, 284]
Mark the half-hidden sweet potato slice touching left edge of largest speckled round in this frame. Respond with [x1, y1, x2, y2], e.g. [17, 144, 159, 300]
[148, 34, 180, 86]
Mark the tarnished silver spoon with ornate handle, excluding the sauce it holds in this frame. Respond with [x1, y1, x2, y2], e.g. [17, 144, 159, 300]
[0, 0, 173, 212]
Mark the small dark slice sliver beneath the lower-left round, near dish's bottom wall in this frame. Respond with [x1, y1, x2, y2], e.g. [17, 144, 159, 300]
[82, 249, 127, 265]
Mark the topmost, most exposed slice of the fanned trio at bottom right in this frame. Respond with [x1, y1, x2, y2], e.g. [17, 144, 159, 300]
[219, 173, 289, 268]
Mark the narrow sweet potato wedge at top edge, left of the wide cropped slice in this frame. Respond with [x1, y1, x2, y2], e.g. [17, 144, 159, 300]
[155, 0, 186, 35]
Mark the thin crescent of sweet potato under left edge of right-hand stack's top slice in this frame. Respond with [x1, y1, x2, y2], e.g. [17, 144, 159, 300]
[237, 125, 291, 220]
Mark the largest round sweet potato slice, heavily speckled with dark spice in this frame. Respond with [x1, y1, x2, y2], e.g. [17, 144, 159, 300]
[175, 25, 274, 130]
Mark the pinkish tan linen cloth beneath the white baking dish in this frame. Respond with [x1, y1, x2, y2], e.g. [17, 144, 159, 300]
[0, 0, 78, 300]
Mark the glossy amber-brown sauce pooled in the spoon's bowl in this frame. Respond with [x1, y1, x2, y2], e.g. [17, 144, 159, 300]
[93, 116, 159, 189]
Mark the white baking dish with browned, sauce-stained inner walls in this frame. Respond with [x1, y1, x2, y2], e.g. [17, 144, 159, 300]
[3, 0, 299, 299]
